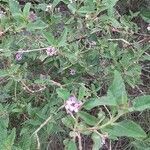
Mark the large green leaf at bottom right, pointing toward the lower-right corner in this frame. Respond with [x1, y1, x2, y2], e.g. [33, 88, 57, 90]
[104, 120, 146, 138]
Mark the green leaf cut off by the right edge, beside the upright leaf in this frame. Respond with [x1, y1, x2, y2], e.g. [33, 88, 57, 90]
[133, 95, 150, 111]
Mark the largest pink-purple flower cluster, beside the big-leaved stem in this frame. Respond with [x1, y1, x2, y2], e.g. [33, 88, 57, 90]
[65, 95, 82, 113]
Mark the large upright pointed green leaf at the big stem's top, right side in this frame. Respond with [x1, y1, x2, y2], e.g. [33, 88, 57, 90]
[108, 70, 127, 105]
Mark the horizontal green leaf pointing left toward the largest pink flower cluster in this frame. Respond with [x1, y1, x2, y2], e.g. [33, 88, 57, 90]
[84, 96, 117, 110]
